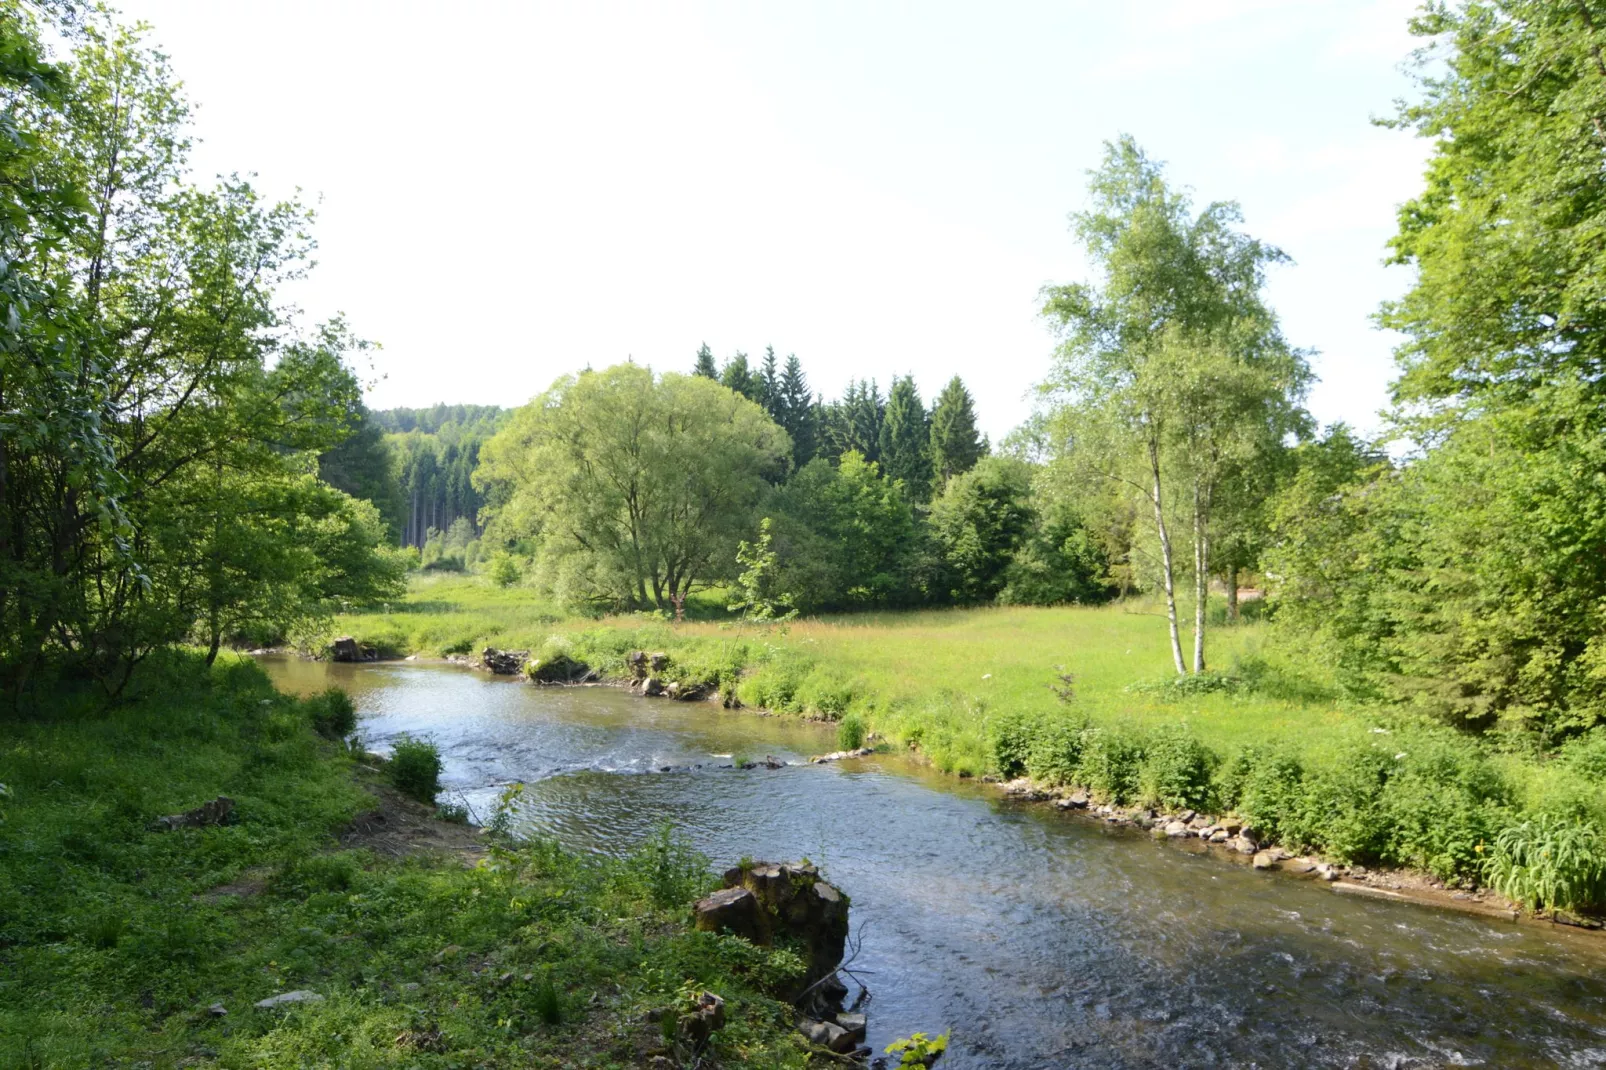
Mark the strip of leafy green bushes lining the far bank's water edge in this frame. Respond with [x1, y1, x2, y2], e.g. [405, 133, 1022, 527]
[401, 623, 1606, 925]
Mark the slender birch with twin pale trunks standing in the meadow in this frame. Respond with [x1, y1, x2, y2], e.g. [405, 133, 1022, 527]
[1042, 137, 1310, 673]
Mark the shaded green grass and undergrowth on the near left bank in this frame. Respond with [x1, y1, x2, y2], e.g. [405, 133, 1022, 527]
[0, 657, 803, 1068]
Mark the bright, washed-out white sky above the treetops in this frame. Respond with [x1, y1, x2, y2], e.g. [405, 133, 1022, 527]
[122, 0, 1428, 440]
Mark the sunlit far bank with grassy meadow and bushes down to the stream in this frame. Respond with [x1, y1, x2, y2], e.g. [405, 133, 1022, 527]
[329, 578, 1606, 909]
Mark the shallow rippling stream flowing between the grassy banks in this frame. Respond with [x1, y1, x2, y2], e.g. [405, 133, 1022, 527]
[265, 659, 1606, 1070]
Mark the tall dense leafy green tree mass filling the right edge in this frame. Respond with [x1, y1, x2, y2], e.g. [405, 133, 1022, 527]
[1277, 0, 1606, 737]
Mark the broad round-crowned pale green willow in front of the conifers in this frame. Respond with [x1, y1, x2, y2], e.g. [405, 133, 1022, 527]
[474, 363, 789, 614]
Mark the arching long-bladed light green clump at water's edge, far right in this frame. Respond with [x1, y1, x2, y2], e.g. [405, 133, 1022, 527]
[1484, 815, 1606, 909]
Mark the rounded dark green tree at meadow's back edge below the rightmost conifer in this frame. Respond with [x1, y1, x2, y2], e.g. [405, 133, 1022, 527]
[931, 456, 1037, 602]
